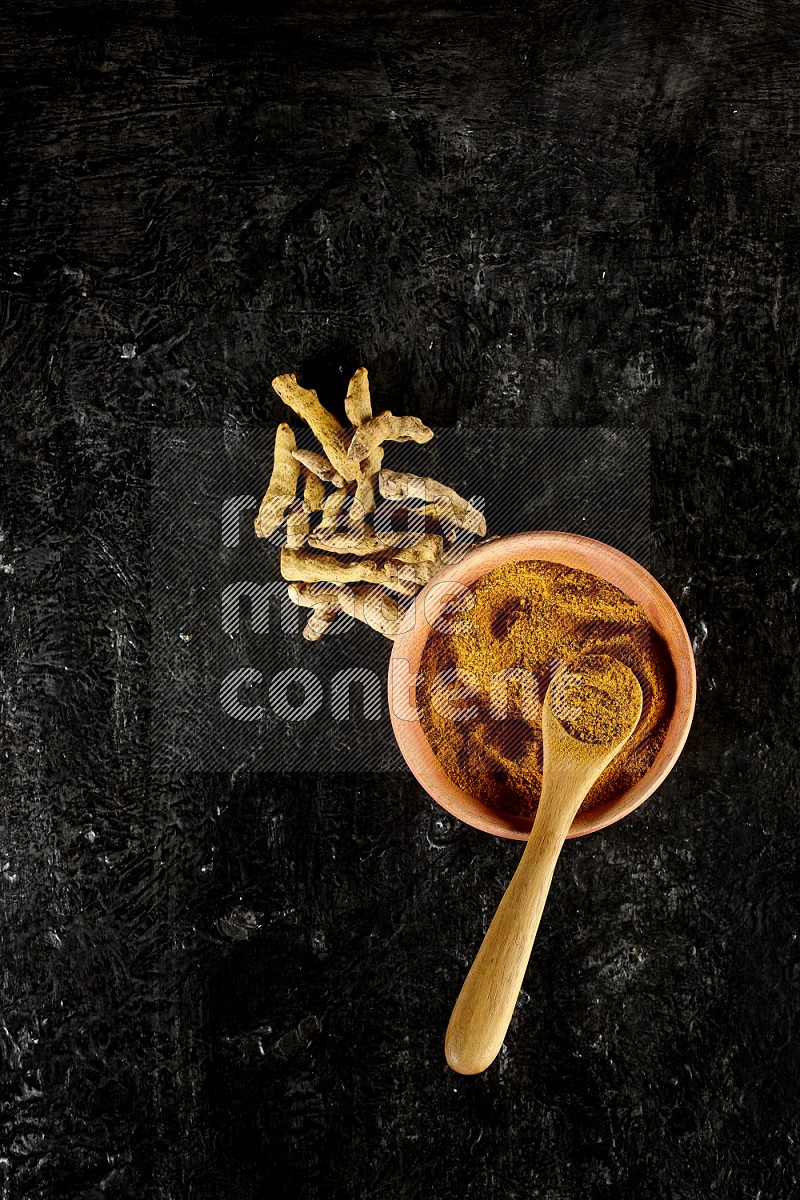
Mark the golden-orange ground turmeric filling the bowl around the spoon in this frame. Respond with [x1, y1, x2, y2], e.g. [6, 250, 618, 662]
[416, 560, 675, 817]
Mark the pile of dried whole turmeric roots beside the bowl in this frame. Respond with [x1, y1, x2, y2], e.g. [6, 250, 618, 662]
[255, 367, 486, 641]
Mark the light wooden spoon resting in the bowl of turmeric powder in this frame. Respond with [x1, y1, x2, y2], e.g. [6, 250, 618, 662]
[445, 656, 642, 1075]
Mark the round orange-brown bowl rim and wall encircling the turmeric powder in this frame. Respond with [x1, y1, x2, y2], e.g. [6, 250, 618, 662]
[389, 530, 696, 840]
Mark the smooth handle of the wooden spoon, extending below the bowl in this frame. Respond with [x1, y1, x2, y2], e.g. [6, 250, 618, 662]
[445, 799, 581, 1075]
